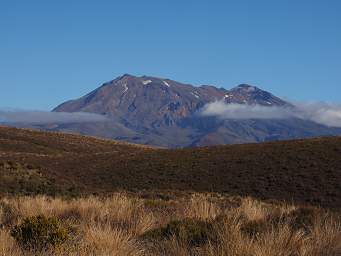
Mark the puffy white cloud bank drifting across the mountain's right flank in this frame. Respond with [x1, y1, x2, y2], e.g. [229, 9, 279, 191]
[200, 101, 341, 127]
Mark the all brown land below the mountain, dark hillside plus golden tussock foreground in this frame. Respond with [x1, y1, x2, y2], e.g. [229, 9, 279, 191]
[0, 127, 341, 256]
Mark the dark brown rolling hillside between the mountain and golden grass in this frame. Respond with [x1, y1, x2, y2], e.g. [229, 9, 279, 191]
[0, 127, 341, 208]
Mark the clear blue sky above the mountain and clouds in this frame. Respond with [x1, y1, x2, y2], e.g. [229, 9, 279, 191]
[0, 0, 341, 110]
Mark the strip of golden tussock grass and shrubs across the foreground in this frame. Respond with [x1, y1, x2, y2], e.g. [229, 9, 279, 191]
[0, 193, 341, 256]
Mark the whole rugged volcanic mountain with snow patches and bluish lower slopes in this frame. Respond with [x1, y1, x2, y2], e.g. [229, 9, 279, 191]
[50, 74, 341, 148]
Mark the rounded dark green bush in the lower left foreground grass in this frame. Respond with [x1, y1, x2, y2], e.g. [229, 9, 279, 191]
[11, 215, 71, 251]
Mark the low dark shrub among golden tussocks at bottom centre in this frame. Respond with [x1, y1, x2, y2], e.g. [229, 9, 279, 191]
[143, 219, 214, 246]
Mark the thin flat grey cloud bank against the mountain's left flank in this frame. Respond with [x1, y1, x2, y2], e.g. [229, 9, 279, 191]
[0, 110, 107, 124]
